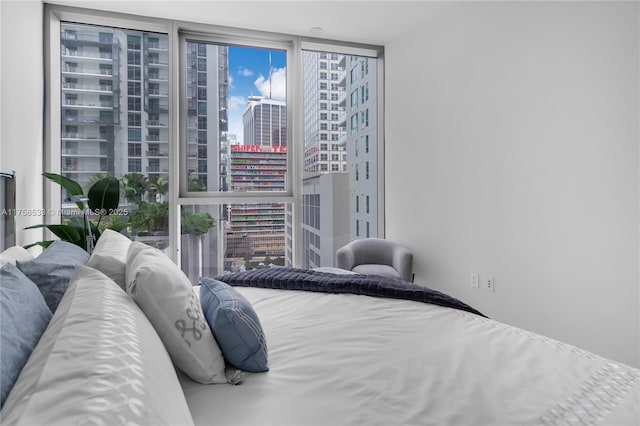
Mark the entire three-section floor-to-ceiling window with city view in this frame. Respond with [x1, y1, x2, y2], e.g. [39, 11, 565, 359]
[47, 6, 383, 282]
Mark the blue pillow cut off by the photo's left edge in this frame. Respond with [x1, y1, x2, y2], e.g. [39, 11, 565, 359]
[0, 264, 51, 407]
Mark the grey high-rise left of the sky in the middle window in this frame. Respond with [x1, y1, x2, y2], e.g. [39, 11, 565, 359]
[181, 41, 229, 280]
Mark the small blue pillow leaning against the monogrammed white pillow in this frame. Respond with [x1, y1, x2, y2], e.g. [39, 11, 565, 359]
[200, 277, 269, 372]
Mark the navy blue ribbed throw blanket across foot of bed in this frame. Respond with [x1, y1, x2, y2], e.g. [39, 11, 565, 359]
[215, 268, 485, 317]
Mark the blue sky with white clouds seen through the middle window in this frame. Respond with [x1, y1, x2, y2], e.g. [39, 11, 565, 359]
[228, 46, 287, 143]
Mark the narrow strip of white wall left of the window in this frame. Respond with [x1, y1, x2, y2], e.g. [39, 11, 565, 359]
[0, 0, 44, 251]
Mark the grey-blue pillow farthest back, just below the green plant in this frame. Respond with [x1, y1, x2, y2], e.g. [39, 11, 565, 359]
[16, 240, 89, 312]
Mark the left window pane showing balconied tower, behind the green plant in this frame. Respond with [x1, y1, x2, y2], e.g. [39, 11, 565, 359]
[54, 22, 170, 249]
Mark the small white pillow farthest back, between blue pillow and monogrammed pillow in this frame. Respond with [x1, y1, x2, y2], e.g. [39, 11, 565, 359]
[87, 229, 131, 289]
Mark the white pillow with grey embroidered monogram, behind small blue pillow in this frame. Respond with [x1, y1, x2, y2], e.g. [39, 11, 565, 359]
[126, 241, 227, 384]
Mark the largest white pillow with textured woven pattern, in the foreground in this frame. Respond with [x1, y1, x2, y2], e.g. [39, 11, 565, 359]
[2, 265, 193, 425]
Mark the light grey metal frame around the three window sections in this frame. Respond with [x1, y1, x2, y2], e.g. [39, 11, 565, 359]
[43, 3, 385, 265]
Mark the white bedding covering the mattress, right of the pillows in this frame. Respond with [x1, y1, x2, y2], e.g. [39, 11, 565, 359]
[180, 287, 640, 425]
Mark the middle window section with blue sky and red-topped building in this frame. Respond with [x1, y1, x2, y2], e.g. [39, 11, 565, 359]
[180, 33, 292, 276]
